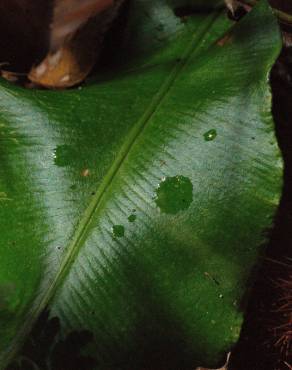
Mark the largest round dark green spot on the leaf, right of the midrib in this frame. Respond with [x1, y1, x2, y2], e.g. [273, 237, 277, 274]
[155, 176, 193, 214]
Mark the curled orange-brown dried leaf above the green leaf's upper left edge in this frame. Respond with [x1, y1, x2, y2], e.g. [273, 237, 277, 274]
[28, 0, 123, 88]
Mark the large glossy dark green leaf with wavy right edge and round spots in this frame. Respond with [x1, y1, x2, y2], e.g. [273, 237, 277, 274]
[0, 0, 282, 370]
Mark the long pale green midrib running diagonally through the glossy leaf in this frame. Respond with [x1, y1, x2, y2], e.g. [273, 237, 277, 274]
[0, 11, 221, 369]
